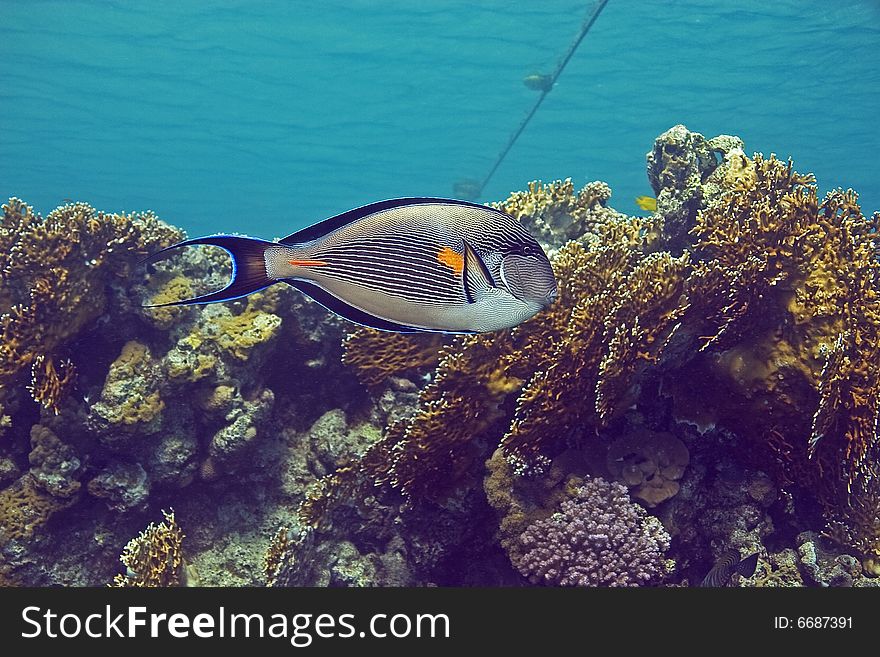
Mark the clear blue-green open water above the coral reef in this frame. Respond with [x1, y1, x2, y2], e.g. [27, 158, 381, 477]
[0, 0, 880, 237]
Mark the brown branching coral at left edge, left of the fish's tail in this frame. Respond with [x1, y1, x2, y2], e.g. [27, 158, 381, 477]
[0, 198, 181, 408]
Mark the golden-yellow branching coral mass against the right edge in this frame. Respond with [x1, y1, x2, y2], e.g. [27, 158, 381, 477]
[688, 155, 880, 555]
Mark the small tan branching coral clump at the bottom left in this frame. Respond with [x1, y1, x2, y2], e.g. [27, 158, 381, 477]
[112, 511, 185, 587]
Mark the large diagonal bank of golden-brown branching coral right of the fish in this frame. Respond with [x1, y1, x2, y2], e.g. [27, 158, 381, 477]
[303, 132, 880, 558]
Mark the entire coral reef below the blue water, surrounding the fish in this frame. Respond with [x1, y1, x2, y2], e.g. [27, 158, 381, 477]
[0, 126, 880, 586]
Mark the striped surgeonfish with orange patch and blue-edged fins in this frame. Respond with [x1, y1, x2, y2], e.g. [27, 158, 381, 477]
[147, 198, 557, 333]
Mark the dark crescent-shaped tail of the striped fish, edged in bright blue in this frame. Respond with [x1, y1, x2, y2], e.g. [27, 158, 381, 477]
[142, 235, 278, 308]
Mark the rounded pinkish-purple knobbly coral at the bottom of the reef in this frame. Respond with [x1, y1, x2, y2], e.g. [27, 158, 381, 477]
[515, 478, 669, 586]
